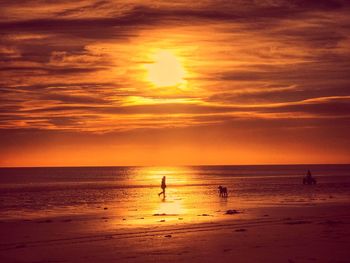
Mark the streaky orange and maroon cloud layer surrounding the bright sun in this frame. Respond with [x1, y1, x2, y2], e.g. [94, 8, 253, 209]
[0, 0, 350, 135]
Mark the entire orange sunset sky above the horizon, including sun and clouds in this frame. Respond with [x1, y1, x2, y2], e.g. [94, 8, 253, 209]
[0, 0, 350, 166]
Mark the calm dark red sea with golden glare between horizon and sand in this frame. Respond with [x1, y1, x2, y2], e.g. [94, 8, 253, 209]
[0, 165, 350, 222]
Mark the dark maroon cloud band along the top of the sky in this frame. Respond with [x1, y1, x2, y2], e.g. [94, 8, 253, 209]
[0, 1, 347, 38]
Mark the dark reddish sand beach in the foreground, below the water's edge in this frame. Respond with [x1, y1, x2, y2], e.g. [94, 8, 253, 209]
[0, 204, 350, 263]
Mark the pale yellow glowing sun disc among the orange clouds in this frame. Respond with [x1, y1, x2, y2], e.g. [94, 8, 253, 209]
[146, 50, 185, 87]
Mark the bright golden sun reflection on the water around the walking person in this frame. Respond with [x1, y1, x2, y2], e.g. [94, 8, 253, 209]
[111, 167, 194, 226]
